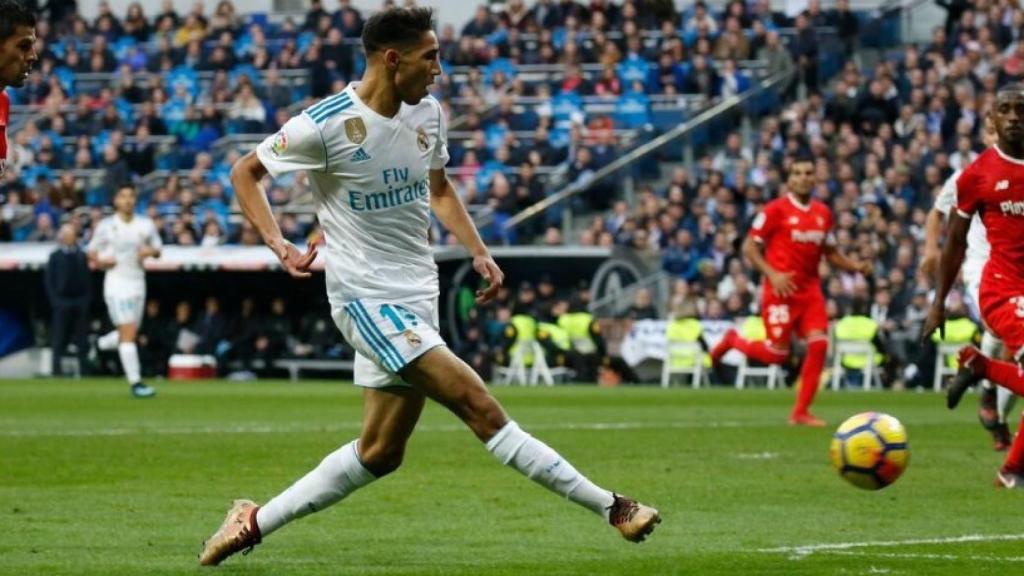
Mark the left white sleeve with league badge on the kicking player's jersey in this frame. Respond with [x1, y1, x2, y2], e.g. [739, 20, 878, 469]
[256, 114, 327, 178]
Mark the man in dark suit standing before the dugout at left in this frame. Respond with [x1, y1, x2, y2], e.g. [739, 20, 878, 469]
[43, 224, 92, 377]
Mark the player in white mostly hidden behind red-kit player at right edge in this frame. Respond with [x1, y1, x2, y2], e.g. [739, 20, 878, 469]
[921, 123, 1017, 451]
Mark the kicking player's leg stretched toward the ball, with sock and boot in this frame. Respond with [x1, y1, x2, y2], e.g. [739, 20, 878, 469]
[402, 346, 660, 542]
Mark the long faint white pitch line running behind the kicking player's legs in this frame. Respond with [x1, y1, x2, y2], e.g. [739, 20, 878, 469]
[0, 421, 765, 438]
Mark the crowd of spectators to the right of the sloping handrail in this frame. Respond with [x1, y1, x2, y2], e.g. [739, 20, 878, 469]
[593, 0, 1024, 379]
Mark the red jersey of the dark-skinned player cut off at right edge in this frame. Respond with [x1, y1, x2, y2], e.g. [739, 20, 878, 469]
[956, 146, 1024, 293]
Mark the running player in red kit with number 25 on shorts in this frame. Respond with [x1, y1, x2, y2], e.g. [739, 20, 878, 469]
[711, 156, 871, 426]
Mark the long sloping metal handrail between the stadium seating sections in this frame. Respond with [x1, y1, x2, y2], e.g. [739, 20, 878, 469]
[499, 62, 796, 231]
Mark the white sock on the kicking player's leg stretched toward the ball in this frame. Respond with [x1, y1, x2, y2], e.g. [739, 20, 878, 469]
[487, 421, 614, 520]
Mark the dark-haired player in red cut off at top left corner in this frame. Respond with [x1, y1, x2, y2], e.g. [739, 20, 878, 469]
[0, 0, 39, 174]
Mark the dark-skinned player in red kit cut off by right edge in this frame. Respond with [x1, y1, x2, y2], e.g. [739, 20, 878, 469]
[922, 84, 1024, 488]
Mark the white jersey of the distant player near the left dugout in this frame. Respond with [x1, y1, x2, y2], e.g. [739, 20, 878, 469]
[89, 214, 163, 293]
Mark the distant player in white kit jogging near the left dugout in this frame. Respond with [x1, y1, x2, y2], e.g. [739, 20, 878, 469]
[88, 186, 163, 398]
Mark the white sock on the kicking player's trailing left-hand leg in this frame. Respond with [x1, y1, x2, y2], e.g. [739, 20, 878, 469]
[256, 440, 377, 537]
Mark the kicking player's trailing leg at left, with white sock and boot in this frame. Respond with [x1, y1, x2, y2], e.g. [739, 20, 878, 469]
[200, 386, 425, 566]
